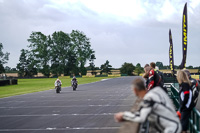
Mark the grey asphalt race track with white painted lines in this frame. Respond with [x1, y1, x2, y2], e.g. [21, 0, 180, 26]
[0, 77, 135, 133]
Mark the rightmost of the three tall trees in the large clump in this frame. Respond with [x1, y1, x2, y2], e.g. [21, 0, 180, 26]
[70, 30, 94, 75]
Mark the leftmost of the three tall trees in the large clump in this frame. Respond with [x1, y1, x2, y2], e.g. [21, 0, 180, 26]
[28, 32, 51, 77]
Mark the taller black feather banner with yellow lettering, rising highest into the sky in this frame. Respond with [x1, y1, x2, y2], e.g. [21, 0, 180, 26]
[179, 3, 188, 69]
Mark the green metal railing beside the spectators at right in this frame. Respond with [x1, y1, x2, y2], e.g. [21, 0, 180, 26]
[165, 83, 200, 133]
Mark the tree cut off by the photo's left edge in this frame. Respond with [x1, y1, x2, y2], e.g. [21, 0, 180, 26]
[0, 43, 10, 74]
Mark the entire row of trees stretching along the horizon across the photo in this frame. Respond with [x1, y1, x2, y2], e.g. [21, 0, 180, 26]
[0, 30, 200, 77]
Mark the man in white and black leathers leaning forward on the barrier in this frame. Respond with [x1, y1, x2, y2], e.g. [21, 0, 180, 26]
[114, 78, 181, 133]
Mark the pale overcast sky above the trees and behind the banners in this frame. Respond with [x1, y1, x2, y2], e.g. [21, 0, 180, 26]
[0, 0, 200, 67]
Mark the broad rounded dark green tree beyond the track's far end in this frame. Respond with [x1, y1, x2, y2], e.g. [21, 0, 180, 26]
[120, 62, 135, 75]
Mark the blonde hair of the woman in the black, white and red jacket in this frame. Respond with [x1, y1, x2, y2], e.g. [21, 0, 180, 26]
[177, 70, 191, 85]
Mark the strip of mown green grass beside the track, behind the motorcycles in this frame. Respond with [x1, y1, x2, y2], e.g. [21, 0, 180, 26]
[0, 77, 113, 98]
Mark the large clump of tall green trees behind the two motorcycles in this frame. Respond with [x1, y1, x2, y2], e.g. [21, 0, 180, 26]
[17, 30, 95, 77]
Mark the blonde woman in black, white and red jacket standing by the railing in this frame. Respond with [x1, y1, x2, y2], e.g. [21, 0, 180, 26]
[177, 70, 192, 133]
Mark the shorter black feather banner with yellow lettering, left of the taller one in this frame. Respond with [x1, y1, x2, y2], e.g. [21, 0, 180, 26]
[169, 29, 174, 76]
